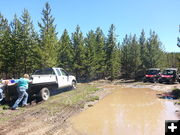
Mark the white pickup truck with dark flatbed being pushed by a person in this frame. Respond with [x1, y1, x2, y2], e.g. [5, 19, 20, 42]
[0, 67, 77, 101]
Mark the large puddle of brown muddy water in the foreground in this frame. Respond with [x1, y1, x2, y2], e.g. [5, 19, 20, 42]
[70, 87, 178, 135]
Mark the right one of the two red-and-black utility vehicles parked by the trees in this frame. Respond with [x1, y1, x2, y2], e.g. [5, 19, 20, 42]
[159, 68, 180, 84]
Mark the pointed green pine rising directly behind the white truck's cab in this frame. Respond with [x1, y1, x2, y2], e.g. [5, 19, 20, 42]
[58, 29, 73, 72]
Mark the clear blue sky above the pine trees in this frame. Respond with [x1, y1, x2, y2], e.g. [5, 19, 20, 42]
[0, 0, 180, 52]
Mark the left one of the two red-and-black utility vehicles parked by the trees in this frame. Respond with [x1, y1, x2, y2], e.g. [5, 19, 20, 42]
[143, 68, 161, 83]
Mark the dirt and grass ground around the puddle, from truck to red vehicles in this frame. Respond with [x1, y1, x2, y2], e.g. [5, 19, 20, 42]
[0, 80, 180, 135]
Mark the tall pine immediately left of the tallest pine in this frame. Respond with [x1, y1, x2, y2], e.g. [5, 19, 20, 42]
[20, 10, 40, 73]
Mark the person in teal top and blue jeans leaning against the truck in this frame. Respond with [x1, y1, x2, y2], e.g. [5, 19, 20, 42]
[12, 74, 31, 110]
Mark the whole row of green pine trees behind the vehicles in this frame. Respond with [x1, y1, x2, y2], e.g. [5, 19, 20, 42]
[0, 3, 180, 81]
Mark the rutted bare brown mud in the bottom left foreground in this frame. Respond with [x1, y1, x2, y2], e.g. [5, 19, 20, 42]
[0, 106, 78, 135]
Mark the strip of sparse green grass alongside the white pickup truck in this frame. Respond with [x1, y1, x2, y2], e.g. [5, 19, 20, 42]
[0, 83, 99, 122]
